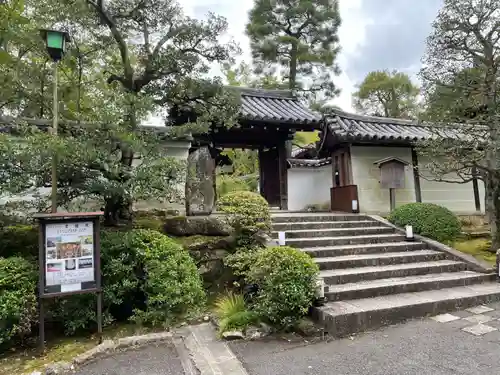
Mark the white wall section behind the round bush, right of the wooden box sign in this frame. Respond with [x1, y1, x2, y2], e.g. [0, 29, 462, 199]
[419, 157, 484, 215]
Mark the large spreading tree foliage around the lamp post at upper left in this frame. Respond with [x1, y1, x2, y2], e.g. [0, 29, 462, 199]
[0, 0, 237, 223]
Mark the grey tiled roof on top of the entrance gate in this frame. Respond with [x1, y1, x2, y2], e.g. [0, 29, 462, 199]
[237, 87, 322, 125]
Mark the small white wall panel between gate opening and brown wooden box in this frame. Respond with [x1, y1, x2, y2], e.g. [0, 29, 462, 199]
[288, 165, 332, 211]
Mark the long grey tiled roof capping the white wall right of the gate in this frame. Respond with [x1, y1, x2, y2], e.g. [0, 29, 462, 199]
[328, 111, 464, 143]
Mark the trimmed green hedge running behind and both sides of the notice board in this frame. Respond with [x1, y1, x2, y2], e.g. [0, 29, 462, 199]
[0, 226, 205, 344]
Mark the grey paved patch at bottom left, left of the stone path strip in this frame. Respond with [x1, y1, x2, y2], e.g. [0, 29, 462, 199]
[75, 344, 185, 375]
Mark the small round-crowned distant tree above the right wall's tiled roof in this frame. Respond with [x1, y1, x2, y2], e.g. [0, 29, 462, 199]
[353, 70, 419, 118]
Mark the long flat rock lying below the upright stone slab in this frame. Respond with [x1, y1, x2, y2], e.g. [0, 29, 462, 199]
[164, 215, 233, 236]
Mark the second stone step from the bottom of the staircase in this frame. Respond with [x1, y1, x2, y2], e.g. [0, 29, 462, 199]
[325, 271, 492, 301]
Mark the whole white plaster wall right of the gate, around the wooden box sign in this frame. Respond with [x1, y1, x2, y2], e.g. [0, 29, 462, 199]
[351, 146, 484, 214]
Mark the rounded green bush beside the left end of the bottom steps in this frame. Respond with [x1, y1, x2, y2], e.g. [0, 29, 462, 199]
[247, 246, 319, 329]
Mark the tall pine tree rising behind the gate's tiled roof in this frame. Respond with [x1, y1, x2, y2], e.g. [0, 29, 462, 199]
[247, 0, 341, 102]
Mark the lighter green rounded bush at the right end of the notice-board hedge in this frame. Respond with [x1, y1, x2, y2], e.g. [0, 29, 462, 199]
[133, 230, 206, 326]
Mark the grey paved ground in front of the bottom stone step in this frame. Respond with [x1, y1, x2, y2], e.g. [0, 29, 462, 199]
[230, 304, 500, 375]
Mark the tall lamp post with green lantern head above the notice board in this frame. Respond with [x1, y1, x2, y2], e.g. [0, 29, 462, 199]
[40, 29, 70, 212]
